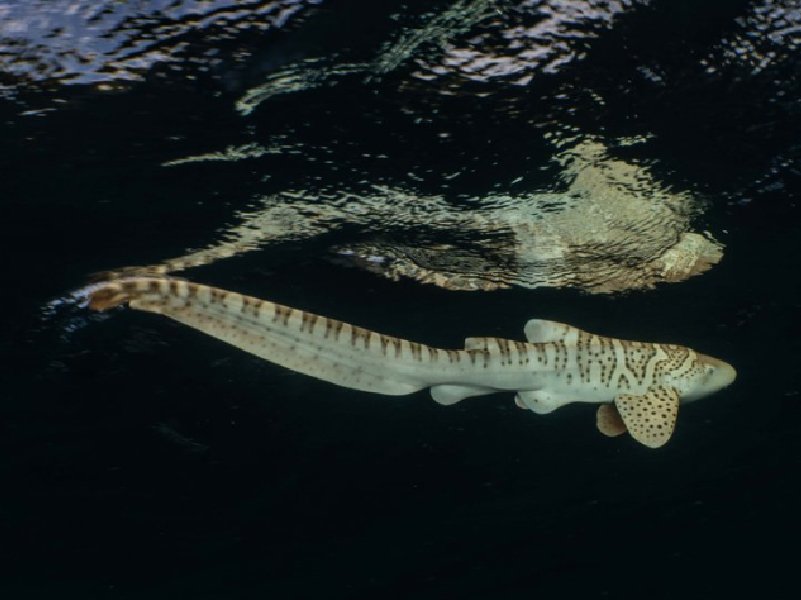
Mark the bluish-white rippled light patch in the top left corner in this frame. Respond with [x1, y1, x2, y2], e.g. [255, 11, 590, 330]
[0, 0, 320, 94]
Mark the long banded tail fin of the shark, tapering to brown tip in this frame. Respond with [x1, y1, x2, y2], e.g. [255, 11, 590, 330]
[87, 277, 433, 396]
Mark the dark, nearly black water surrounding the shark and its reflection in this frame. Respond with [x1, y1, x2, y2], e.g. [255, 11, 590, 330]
[0, 0, 801, 598]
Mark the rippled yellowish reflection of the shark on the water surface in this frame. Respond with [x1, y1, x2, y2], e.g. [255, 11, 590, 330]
[128, 139, 723, 293]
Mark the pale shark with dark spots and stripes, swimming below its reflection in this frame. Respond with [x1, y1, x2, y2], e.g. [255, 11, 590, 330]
[85, 276, 736, 448]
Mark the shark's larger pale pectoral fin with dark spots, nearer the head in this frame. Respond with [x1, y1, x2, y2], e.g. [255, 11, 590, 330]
[615, 387, 679, 448]
